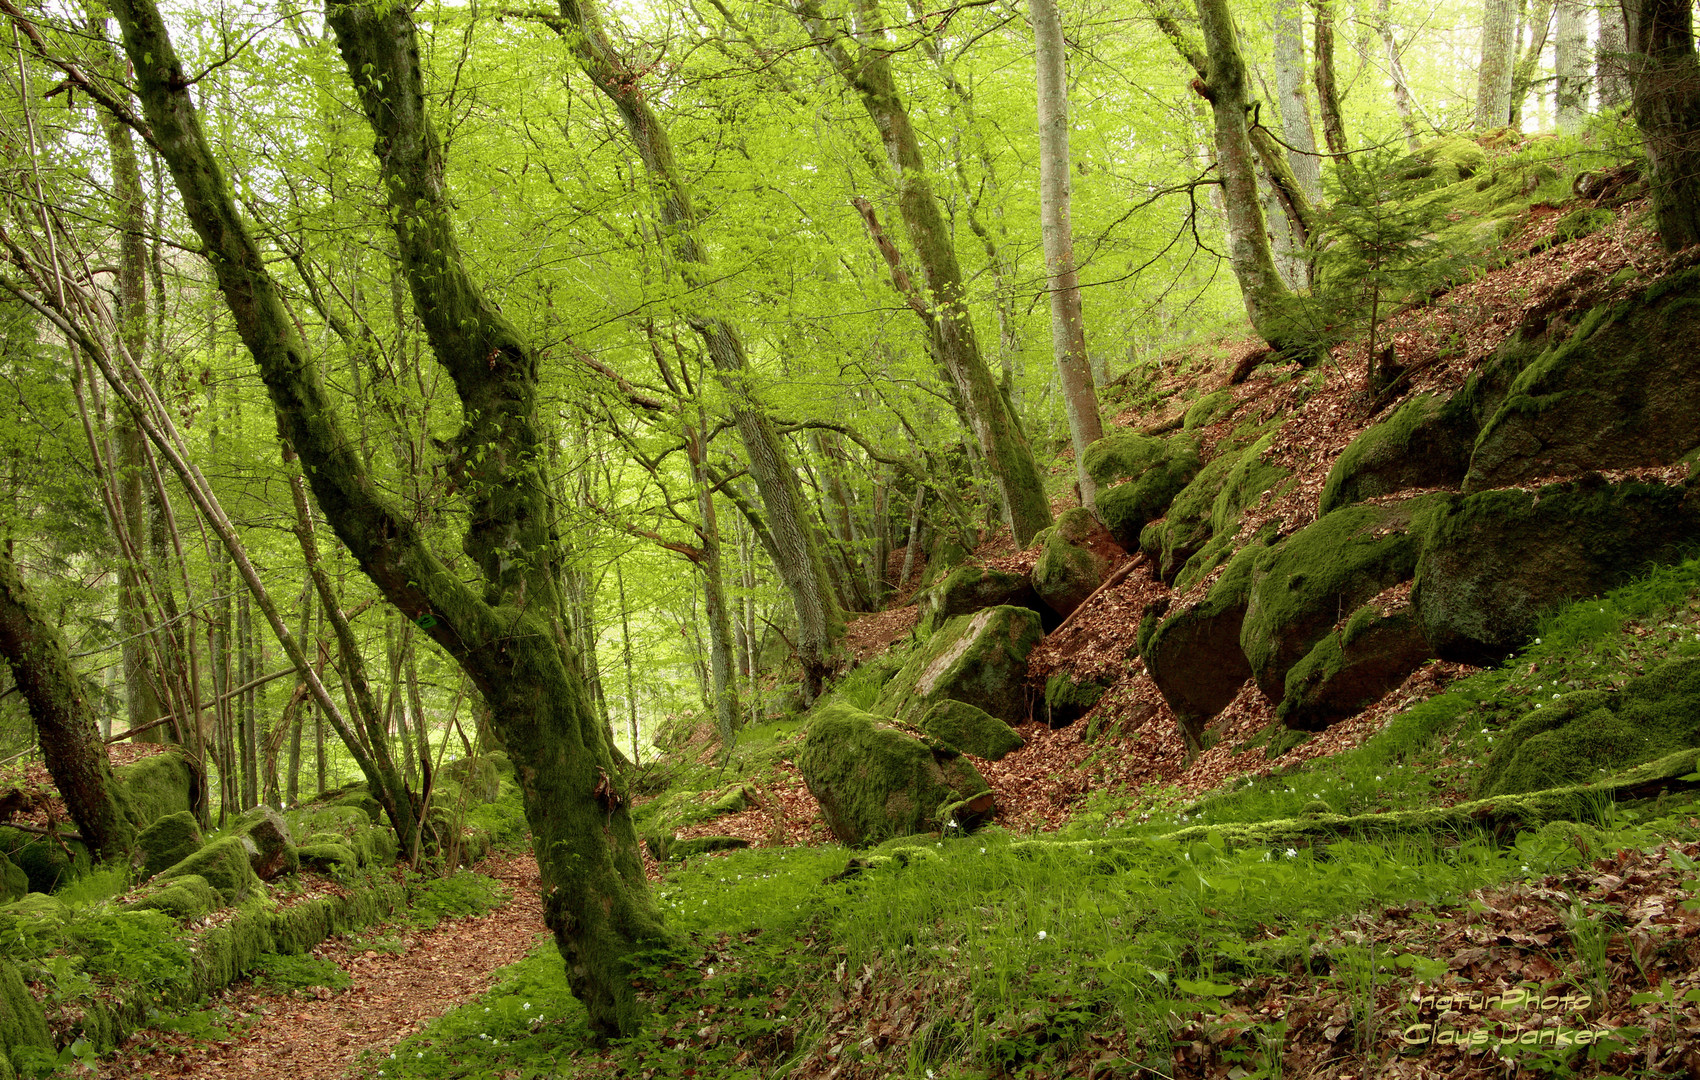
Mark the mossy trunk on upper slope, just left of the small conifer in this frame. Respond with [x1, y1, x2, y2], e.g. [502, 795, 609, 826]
[1193, 0, 1301, 350]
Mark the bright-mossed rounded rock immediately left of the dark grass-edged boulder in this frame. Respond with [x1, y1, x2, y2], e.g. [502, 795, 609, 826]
[1239, 495, 1448, 702]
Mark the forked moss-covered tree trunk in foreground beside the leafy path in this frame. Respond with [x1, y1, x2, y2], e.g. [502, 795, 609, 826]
[112, 0, 665, 1034]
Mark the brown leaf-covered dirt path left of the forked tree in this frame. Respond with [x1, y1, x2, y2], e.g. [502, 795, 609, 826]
[100, 854, 547, 1080]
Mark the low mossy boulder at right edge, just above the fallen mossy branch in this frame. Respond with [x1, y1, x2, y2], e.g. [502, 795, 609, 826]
[1477, 657, 1700, 796]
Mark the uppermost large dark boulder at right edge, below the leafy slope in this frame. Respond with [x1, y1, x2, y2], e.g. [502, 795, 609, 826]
[1464, 267, 1700, 492]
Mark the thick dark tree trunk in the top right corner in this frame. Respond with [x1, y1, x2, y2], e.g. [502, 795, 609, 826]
[1624, 0, 1700, 252]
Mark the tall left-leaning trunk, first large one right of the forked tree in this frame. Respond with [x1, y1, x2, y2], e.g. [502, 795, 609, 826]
[554, 0, 845, 702]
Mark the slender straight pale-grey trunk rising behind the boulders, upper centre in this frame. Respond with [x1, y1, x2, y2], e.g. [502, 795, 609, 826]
[1030, 0, 1103, 510]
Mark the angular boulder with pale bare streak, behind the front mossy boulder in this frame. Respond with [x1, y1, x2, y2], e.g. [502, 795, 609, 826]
[876, 605, 1044, 723]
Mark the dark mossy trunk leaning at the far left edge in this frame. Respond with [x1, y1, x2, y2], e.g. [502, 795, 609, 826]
[0, 537, 136, 859]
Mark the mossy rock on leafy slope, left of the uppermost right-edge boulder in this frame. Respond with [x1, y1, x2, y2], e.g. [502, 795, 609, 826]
[1318, 395, 1476, 515]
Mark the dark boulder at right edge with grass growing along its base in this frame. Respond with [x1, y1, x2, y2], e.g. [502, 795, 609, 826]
[1411, 475, 1700, 665]
